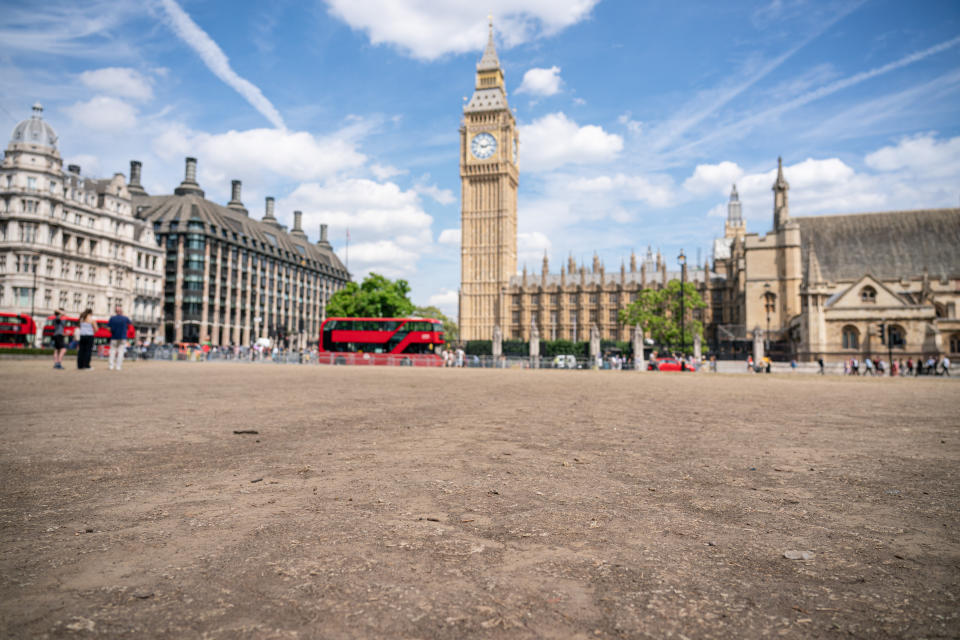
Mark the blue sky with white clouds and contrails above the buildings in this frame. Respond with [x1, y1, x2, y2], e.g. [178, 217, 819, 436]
[0, 0, 960, 312]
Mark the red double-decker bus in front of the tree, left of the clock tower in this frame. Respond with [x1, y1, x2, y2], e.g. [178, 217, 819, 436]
[319, 318, 443, 367]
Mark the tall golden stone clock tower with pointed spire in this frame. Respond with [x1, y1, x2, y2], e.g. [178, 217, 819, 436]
[460, 19, 518, 340]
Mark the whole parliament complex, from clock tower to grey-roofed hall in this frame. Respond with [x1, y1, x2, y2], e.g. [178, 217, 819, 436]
[459, 24, 960, 361]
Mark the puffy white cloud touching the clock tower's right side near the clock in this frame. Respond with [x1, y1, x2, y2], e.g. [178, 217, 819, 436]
[520, 112, 623, 172]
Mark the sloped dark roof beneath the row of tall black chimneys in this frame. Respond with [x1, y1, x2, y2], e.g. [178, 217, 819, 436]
[133, 193, 349, 278]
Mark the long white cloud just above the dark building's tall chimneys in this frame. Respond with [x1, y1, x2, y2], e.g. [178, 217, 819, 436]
[154, 125, 366, 184]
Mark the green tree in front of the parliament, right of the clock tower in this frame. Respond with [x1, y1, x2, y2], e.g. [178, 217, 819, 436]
[620, 280, 707, 353]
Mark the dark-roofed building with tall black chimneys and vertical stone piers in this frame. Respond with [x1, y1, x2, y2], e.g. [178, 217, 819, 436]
[129, 158, 350, 348]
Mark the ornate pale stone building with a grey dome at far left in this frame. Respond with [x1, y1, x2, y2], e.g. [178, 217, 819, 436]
[0, 104, 163, 340]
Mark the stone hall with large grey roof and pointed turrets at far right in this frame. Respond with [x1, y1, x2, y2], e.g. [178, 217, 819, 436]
[708, 162, 960, 360]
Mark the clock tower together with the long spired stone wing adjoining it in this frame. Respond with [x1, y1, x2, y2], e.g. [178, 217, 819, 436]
[459, 23, 710, 341]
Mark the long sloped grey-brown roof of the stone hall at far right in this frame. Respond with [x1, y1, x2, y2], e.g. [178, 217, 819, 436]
[792, 209, 960, 282]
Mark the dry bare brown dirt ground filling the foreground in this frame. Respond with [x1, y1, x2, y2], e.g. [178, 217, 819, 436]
[0, 361, 960, 639]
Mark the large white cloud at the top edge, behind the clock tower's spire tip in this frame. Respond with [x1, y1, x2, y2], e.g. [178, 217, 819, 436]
[326, 0, 599, 60]
